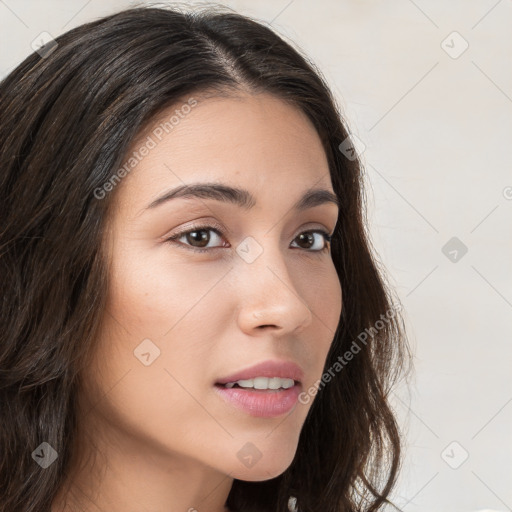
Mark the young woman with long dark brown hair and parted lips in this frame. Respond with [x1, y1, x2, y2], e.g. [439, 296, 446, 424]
[0, 7, 408, 512]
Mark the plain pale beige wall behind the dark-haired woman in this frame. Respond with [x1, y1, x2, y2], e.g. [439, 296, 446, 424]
[0, 0, 512, 512]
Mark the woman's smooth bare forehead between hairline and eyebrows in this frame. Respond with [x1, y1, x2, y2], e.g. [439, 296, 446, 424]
[119, 95, 330, 210]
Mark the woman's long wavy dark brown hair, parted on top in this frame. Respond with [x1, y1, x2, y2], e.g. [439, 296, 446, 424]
[0, 7, 411, 512]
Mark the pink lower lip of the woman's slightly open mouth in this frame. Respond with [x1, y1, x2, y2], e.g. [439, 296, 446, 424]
[215, 384, 300, 418]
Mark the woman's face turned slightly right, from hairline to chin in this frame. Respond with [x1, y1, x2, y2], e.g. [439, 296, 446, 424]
[85, 94, 342, 488]
